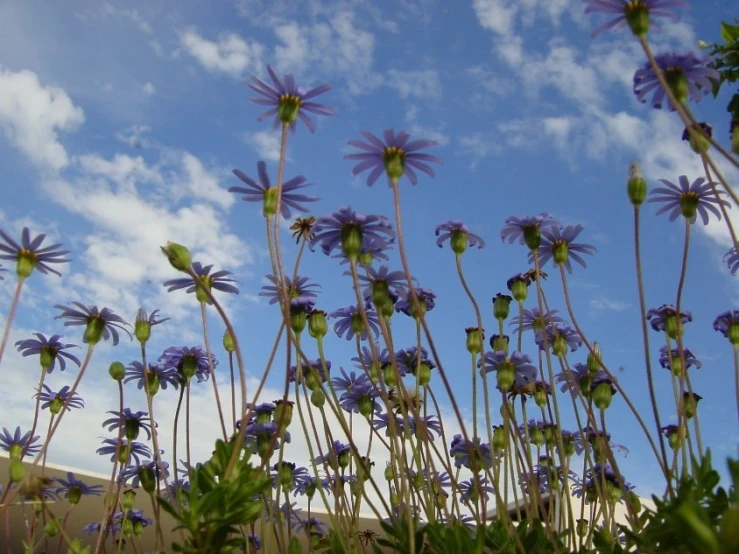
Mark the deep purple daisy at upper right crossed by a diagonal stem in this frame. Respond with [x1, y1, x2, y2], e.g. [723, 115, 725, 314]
[634, 52, 720, 111]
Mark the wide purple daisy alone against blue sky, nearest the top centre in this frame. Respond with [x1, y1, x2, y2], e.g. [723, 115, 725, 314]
[344, 128, 443, 186]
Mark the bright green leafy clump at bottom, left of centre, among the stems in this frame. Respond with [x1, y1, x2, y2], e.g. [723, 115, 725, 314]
[158, 437, 271, 554]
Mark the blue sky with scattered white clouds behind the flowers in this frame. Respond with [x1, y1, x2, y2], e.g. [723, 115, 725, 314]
[0, 0, 739, 498]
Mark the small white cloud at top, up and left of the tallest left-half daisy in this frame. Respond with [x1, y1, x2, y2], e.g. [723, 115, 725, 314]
[180, 28, 264, 78]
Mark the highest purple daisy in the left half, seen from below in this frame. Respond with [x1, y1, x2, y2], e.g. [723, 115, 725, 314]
[247, 66, 336, 133]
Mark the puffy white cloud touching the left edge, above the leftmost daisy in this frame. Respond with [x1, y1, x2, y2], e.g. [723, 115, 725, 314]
[0, 67, 85, 171]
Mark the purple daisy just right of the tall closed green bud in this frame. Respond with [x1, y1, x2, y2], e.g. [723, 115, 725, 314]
[648, 175, 731, 225]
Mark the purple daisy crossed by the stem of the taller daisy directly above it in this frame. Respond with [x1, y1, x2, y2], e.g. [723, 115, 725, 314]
[228, 161, 318, 219]
